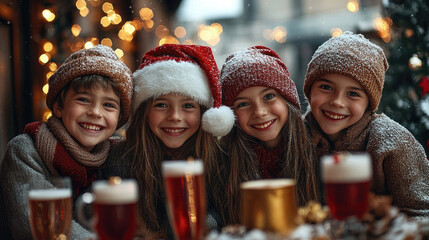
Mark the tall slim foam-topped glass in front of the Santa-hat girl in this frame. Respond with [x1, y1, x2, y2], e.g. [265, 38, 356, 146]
[162, 160, 206, 240]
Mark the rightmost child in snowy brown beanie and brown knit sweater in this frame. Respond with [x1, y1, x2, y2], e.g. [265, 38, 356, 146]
[304, 32, 429, 216]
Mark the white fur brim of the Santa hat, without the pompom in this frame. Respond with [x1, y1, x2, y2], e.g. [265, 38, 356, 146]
[132, 60, 213, 113]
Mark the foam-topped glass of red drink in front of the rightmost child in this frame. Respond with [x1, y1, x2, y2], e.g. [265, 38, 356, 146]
[321, 153, 372, 220]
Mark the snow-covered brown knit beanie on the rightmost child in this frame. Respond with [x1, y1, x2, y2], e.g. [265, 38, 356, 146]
[304, 32, 389, 111]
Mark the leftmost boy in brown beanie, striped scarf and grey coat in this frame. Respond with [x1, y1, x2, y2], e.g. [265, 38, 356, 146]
[0, 45, 133, 239]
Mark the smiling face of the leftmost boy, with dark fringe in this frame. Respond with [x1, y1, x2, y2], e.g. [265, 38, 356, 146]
[53, 85, 121, 152]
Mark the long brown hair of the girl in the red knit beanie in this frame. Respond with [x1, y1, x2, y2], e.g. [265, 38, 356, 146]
[215, 101, 318, 224]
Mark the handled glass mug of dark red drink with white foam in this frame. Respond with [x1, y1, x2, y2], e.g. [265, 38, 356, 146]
[76, 177, 138, 240]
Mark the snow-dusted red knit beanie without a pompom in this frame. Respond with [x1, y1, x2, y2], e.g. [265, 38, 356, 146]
[221, 46, 301, 109]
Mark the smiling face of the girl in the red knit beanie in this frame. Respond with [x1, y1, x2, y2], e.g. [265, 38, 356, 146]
[233, 87, 288, 148]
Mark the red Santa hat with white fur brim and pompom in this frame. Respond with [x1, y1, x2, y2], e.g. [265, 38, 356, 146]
[132, 44, 235, 136]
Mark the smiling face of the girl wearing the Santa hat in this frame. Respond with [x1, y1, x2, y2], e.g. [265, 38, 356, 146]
[149, 94, 201, 148]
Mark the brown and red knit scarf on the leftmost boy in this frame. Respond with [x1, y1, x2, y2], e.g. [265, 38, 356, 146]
[24, 116, 110, 194]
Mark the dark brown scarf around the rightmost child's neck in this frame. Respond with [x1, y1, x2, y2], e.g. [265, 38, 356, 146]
[305, 111, 376, 159]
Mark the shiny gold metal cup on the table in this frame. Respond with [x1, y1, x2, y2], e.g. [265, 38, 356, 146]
[240, 179, 297, 234]
